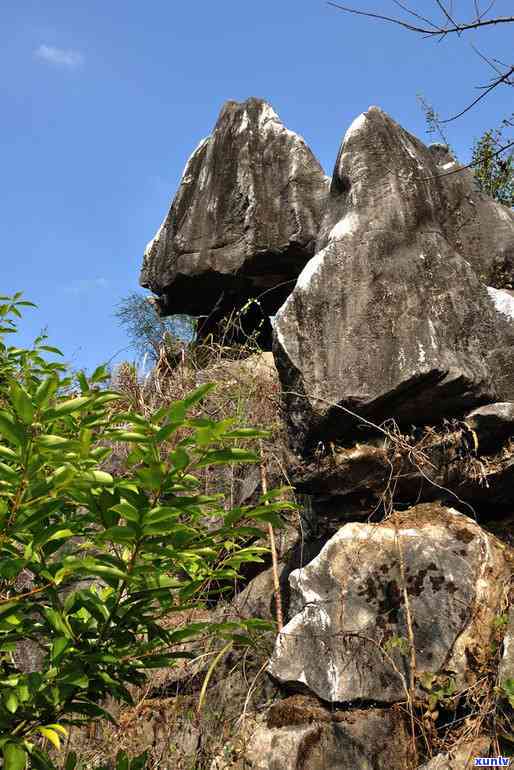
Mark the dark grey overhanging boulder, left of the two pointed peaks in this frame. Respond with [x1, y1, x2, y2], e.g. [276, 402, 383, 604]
[140, 98, 328, 330]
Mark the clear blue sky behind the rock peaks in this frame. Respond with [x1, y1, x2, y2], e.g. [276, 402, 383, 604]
[0, 0, 513, 369]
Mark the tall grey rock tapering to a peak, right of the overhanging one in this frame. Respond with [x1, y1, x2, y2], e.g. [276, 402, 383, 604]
[274, 107, 512, 452]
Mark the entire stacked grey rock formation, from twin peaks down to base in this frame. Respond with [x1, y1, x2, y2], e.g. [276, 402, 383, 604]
[141, 99, 514, 770]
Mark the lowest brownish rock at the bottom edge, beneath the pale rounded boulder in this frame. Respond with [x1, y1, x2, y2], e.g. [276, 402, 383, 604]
[210, 696, 412, 770]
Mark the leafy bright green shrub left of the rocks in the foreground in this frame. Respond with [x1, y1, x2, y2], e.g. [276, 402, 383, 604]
[0, 294, 287, 770]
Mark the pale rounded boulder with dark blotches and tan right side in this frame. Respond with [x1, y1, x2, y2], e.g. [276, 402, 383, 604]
[269, 504, 511, 704]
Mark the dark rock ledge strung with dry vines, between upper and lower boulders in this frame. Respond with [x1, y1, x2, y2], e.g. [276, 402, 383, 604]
[290, 416, 514, 522]
